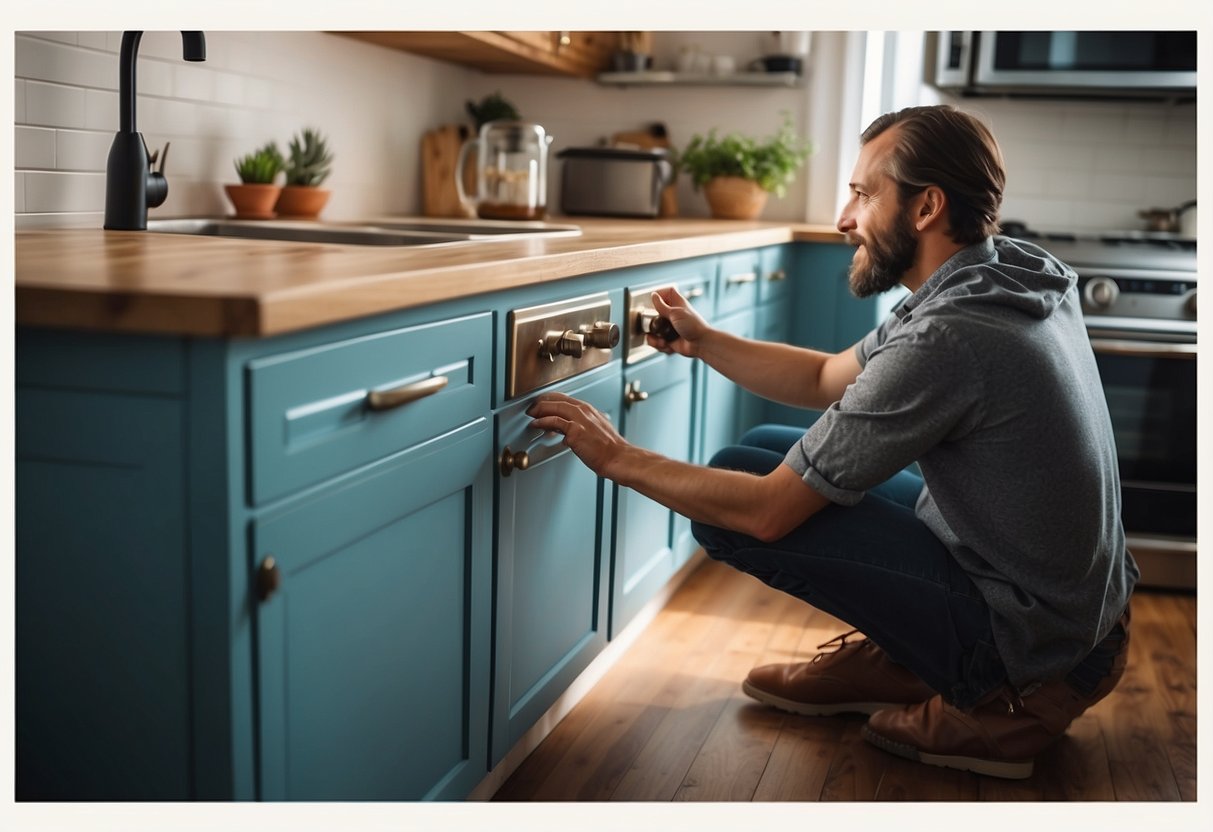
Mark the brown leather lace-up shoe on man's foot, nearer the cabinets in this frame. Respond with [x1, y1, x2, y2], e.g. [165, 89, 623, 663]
[741, 629, 935, 717]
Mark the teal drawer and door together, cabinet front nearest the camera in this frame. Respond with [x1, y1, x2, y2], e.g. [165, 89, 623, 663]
[247, 314, 492, 800]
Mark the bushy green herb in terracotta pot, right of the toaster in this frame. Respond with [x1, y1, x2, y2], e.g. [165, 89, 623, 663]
[678, 113, 813, 220]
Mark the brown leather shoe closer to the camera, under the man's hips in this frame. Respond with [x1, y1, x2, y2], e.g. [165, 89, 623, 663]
[862, 614, 1129, 780]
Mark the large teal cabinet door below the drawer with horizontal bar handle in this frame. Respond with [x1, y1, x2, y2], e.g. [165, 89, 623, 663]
[251, 417, 492, 800]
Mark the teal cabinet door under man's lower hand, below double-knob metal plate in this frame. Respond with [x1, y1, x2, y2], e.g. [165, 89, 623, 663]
[491, 361, 620, 765]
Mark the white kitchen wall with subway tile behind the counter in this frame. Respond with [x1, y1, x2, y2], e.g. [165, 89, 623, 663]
[13, 30, 1196, 230]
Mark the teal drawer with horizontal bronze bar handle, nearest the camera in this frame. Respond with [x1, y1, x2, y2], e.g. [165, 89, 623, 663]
[246, 313, 492, 503]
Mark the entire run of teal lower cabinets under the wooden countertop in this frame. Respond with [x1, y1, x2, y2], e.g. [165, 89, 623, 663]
[15, 246, 803, 800]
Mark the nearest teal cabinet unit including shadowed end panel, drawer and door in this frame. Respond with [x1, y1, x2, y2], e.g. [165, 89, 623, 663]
[16, 304, 492, 800]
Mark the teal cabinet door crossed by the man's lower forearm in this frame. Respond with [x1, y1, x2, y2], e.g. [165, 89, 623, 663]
[610, 355, 694, 638]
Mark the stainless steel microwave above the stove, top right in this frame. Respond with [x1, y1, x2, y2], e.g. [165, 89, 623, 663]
[932, 30, 1196, 96]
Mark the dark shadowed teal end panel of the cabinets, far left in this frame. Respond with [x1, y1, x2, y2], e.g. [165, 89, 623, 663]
[15, 390, 195, 800]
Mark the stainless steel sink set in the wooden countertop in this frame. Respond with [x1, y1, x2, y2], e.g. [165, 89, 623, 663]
[148, 217, 581, 246]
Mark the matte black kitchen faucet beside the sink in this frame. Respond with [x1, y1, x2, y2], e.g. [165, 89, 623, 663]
[106, 32, 206, 230]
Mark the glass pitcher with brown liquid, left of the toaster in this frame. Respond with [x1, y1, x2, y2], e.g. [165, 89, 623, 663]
[455, 120, 552, 220]
